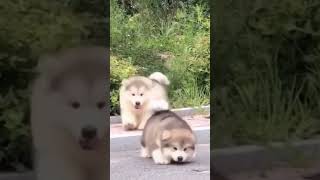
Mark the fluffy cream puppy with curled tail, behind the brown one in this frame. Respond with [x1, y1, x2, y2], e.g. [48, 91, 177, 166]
[120, 72, 170, 130]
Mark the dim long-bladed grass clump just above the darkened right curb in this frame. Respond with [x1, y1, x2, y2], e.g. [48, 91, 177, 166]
[212, 57, 319, 147]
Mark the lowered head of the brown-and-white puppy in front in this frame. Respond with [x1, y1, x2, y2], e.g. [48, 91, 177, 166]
[161, 129, 196, 163]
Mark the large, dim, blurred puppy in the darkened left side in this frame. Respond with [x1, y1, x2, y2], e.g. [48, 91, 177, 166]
[31, 48, 109, 180]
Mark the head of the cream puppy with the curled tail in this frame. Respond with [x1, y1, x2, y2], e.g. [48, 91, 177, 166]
[122, 76, 152, 110]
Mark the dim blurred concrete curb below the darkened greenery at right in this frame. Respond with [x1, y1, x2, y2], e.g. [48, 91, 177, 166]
[211, 138, 320, 174]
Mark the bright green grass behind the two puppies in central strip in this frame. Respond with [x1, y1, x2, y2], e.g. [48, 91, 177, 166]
[111, 0, 210, 113]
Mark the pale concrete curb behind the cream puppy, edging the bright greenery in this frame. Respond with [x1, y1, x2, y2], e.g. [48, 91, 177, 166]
[110, 106, 210, 124]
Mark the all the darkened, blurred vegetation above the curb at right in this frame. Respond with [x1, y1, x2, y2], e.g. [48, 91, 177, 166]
[212, 0, 320, 147]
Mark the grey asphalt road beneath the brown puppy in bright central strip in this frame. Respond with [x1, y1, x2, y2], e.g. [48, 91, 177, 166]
[110, 144, 210, 180]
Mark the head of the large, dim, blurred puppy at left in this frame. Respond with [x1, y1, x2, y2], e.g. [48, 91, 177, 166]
[38, 49, 108, 150]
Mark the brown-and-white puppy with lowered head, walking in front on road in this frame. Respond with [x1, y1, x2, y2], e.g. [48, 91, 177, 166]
[141, 110, 196, 164]
